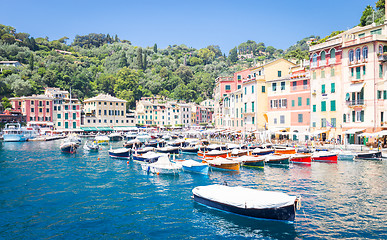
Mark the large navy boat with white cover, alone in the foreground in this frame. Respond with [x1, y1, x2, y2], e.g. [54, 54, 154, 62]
[192, 184, 301, 221]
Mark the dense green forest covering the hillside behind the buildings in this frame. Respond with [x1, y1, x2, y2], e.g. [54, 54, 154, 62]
[0, 0, 385, 108]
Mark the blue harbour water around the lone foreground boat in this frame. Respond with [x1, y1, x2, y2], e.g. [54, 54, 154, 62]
[0, 141, 387, 239]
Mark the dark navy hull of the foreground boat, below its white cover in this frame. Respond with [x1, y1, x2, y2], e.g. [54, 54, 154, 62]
[194, 194, 296, 221]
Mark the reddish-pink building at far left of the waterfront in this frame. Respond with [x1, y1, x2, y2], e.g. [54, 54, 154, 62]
[10, 95, 53, 126]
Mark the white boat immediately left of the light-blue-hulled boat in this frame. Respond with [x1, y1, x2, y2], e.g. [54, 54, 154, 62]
[141, 155, 182, 174]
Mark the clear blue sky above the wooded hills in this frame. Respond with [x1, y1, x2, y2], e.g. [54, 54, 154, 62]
[0, 0, 377, 55]
